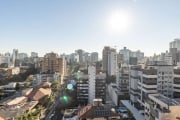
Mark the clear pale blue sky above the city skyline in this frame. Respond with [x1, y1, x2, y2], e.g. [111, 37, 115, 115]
[0, 0, 180, 56]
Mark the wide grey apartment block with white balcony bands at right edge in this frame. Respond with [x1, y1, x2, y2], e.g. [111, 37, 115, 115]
[130, 62, 180, 116]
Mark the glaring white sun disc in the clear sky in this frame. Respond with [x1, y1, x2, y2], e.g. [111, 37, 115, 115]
[108, 10, 131, 33]
